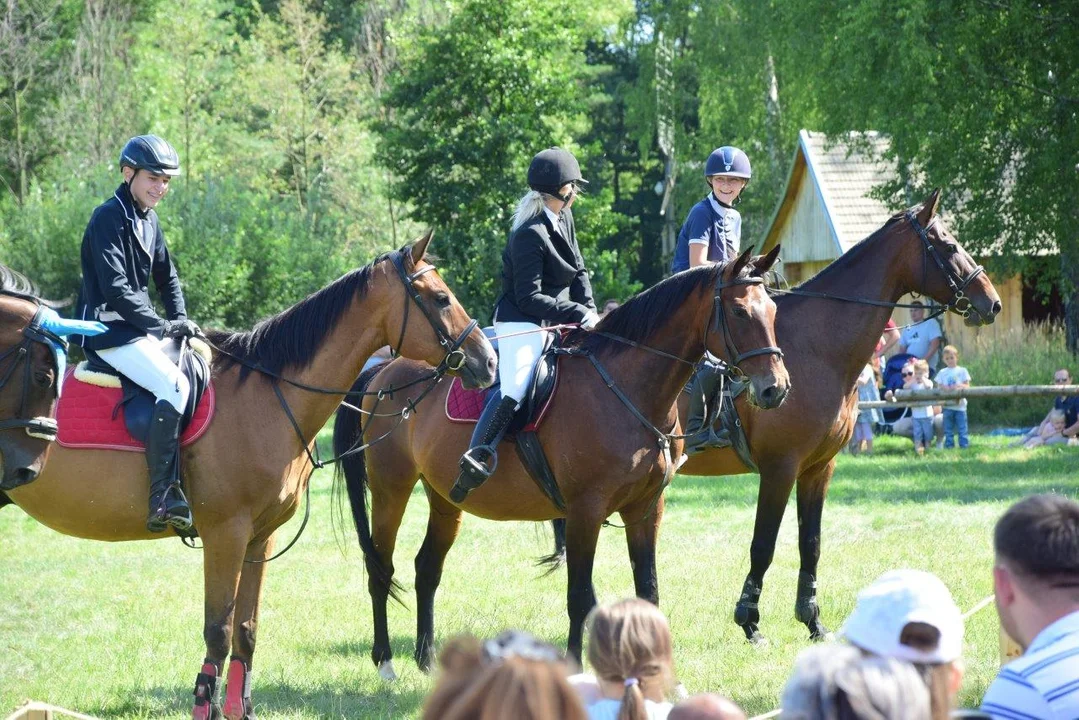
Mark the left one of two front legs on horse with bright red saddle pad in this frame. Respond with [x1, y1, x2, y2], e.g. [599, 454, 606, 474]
[192, 524, 249, 720]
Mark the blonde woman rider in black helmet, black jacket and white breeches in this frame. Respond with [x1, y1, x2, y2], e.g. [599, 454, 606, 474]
[450, 148, 600, 503]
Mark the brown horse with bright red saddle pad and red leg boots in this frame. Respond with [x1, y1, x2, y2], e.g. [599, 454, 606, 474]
[1, 233, 496, 719]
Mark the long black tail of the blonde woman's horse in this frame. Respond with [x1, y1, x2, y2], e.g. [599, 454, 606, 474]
[333, 364, 405, 606]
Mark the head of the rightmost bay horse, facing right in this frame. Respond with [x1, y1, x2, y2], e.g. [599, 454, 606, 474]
[902, 188, 1000, 327]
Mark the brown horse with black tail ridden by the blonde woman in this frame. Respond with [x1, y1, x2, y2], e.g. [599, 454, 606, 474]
[334, 248, 788, 679]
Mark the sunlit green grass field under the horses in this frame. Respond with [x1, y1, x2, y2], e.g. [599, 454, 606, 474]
[0, 437, 1079, 719]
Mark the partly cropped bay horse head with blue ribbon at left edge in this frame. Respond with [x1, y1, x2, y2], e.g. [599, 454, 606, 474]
[0, 289, 62, 489]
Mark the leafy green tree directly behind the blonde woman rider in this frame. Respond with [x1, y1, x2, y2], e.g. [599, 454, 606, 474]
[381, 0, 634, 316]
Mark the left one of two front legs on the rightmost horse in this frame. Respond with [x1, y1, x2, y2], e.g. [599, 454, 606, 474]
[735, 467, 794, 644]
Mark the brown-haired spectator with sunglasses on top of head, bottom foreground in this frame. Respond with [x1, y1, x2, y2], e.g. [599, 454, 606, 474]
[423, 630, 588, 720]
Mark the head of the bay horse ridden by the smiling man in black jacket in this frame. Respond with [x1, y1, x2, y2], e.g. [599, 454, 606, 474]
[385, 230, 498, 388]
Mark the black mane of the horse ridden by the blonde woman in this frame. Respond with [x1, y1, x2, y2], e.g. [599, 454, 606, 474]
[566, 263, 738, 353]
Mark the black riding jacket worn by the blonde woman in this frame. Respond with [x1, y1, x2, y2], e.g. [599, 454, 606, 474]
[494, 208, 596, 325]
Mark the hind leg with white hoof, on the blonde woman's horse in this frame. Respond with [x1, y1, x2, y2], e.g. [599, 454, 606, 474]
[364, 474, 415, 680]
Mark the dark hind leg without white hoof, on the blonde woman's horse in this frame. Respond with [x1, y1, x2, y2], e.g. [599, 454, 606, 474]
[415, 485, 461, 673]
